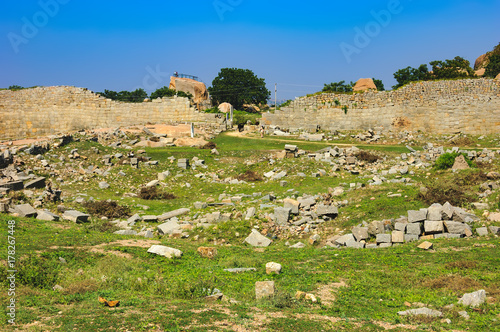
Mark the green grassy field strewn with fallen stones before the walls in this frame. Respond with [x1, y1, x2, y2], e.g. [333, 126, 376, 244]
[0, 134, 500, 331]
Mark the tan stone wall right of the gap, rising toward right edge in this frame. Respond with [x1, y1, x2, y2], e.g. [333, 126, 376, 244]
[262, 79, 500, 135]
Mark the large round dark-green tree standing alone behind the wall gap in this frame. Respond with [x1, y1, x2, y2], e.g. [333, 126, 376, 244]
[208, 68, 271, 109]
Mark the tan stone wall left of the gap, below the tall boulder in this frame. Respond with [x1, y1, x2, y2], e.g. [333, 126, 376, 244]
[0, 86, 220, 140]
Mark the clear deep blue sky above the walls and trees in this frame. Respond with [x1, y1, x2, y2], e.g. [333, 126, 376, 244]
[0, 0, 500, 99]
